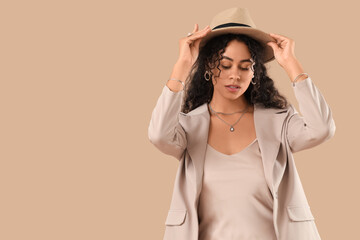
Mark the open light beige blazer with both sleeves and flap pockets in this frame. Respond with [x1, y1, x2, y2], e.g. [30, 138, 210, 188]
[148, 77, 335, 240]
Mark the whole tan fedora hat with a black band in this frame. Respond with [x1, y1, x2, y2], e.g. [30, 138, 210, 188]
[200, 7, 276, 63]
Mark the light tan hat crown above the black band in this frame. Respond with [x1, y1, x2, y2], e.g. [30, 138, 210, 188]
[210, 7, 256, 29]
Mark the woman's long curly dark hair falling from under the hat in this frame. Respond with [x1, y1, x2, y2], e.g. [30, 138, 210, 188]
[181, 33, 288, 113]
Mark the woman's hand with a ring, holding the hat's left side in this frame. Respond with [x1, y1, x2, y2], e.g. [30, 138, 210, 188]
[178, 23, 211, 67]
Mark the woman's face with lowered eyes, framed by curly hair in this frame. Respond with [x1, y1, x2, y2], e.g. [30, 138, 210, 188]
[212, 40, 254, 100]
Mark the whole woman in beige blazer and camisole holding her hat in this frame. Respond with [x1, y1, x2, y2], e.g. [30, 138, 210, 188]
[148, 8, 335, 240]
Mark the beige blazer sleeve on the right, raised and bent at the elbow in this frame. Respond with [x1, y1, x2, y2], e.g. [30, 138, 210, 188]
[286, 77, 336, 153]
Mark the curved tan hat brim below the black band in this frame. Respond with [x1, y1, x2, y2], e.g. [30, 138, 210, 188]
[199, 27, 276, 63]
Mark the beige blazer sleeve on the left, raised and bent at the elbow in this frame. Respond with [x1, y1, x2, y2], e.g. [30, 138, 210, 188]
[148, 85, 187, 161]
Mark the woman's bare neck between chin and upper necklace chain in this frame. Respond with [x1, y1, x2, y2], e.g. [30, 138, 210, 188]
[210, 95, 251, 113]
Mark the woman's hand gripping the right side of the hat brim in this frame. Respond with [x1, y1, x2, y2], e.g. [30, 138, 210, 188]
[267, 33, 296, 68]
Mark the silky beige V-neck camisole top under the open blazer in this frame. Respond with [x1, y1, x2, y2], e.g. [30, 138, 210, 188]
[198, 138, 276, 240]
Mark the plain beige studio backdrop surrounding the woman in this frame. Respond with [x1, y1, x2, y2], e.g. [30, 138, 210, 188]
[0, 0, 360, 240]
